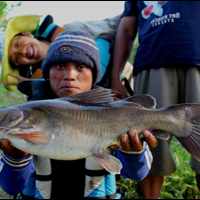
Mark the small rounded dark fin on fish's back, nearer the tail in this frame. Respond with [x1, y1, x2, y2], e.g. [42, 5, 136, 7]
[122, 94, 156, 109]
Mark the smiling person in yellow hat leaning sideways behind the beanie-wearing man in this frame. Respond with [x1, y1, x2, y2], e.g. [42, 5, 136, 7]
[0, 15, 119, 91]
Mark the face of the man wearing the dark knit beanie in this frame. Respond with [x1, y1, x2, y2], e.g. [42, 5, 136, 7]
[49, 62, 93, 98]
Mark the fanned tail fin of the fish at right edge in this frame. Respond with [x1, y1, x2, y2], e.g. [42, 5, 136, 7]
[168, 103, 200, 161]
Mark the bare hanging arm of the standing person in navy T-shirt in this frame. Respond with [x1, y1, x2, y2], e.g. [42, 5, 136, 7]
[110, 16, 138, 99]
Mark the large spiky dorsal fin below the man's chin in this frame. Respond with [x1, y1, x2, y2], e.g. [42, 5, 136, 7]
[59, 87, 118, 106]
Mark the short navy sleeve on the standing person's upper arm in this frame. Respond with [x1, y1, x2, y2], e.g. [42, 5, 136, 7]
[121, 1, 139, 17]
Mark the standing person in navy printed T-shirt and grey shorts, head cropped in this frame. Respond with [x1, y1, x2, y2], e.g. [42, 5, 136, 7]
[111, 1, 200, 199]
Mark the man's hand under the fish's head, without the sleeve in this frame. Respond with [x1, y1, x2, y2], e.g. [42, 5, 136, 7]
[0, 139, 28, 159]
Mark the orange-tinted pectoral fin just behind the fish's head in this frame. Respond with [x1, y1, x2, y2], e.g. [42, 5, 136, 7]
[9, 131, 54, 144]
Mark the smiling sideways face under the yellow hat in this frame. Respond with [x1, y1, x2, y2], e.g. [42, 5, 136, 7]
[8, 32, 46, 65]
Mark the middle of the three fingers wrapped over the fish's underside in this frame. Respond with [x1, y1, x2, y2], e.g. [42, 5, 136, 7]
[128, 129, 143, 151]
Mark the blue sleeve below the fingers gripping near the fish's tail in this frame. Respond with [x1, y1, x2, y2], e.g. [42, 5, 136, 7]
[117, 143, 153, 181]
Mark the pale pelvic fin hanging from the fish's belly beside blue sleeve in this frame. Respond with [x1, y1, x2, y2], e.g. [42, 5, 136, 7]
[92, 151, 122, 174]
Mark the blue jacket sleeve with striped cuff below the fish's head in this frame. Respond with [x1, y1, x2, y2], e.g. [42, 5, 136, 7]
[0, 153, 34, 195]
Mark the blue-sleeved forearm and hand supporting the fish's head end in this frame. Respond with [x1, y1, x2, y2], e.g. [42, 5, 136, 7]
[0, 139, 34, 195]
